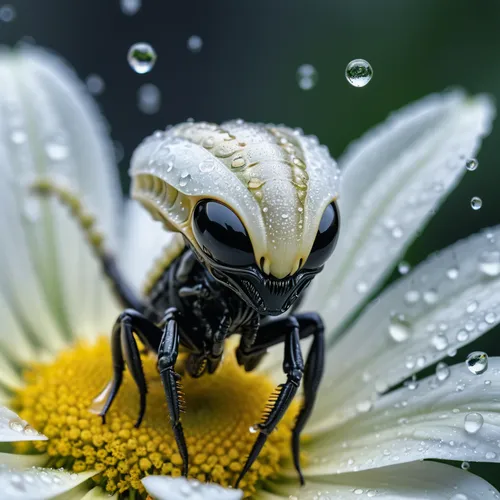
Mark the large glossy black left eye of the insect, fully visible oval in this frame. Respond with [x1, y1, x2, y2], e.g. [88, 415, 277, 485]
[193, 200, 255, 267]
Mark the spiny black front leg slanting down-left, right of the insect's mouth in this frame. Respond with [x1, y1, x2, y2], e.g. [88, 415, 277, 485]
[235, 316, 304, 487]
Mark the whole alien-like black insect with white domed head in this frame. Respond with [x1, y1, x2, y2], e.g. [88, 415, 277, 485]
[35, 120, 340, 486]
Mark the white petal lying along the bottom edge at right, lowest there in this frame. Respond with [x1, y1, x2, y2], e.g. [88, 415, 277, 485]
[270, 462, 500, 500]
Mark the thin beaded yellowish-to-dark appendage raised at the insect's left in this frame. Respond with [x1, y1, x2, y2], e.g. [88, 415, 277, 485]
[31, 179, 144, 311]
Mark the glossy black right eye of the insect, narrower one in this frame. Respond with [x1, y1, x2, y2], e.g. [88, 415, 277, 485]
[304, 201, 340, 269]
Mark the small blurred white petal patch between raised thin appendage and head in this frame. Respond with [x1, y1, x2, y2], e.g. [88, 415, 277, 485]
[120, 201, 183, 292]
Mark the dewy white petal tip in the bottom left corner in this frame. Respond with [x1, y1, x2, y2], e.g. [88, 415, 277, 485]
[0, 467, 95, 500]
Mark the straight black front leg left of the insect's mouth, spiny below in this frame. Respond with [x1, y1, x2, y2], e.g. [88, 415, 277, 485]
[158, 308, 188, 476]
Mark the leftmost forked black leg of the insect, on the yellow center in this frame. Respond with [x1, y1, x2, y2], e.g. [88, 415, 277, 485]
[94, 309, 161, 427]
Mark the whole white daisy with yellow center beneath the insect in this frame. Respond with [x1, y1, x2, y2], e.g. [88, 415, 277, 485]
[0, 49, 500, 500]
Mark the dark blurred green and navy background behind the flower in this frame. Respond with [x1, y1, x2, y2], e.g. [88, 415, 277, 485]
[0, 0, 500, 488]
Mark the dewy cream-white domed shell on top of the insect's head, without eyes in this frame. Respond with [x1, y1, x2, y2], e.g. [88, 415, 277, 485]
[131, 120, 339, 278]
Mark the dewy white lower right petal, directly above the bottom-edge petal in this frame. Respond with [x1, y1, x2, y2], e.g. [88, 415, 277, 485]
[304, 358, 500, 475]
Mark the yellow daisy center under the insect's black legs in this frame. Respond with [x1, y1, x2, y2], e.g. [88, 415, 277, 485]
[13, 338, 297, 497]
